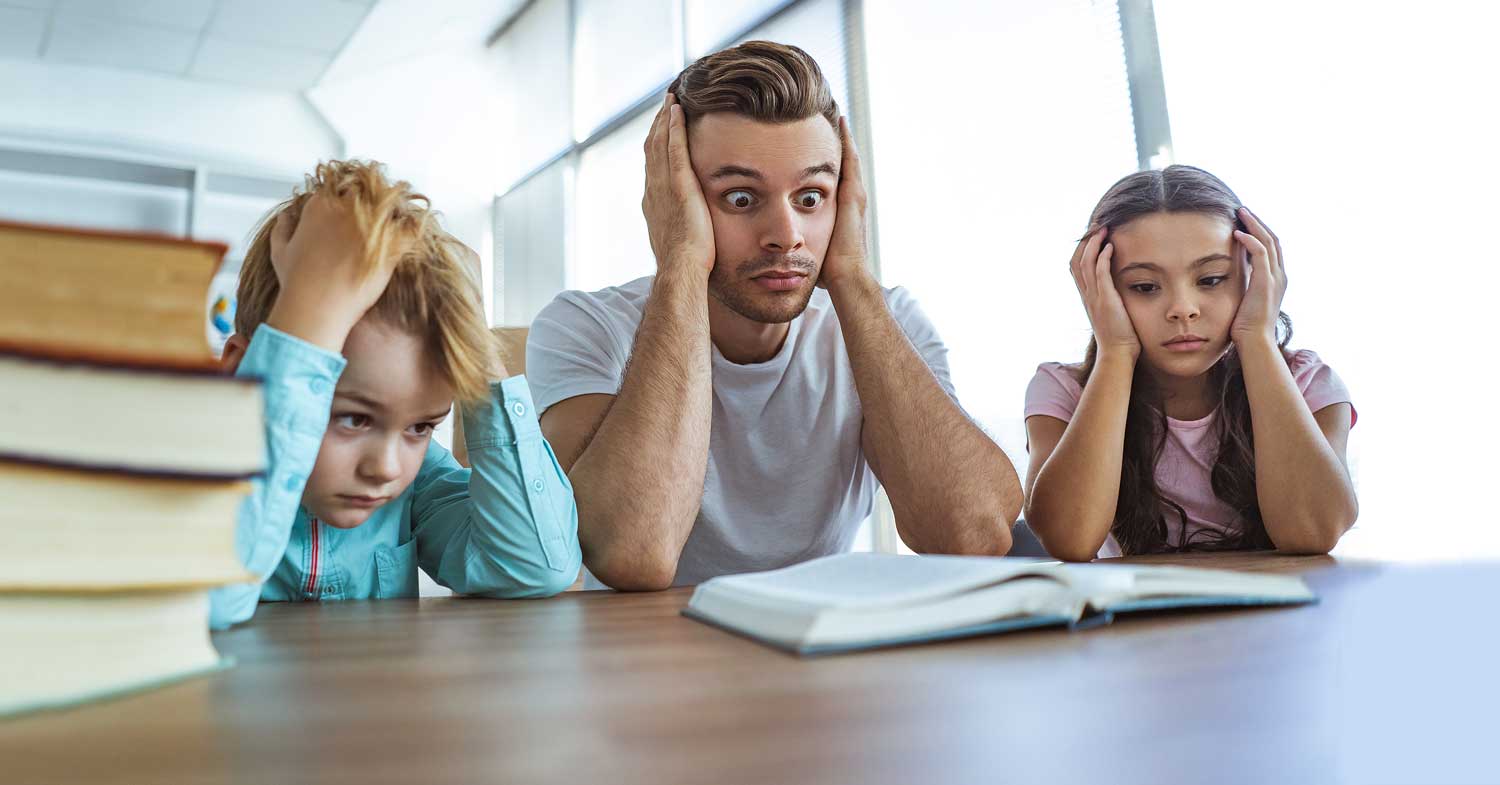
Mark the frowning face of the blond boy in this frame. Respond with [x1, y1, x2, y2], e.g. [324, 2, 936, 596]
[302, 315, 453, 528]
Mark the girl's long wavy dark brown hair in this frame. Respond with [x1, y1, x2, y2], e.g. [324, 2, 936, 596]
[1079, 165, 1292, 555]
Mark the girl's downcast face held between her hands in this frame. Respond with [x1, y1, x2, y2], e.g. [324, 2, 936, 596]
[1109, 213, 1247, 378]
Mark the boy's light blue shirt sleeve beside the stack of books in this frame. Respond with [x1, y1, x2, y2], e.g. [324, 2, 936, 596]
[209, 324, 345, 629]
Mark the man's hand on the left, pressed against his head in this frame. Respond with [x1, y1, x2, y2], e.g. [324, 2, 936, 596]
[641, 93, 714, 273]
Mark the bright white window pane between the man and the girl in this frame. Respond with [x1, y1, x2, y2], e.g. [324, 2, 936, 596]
[866, 0, 1136, 486]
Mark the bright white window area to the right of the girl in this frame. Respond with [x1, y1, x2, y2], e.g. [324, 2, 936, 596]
[1155, 0, 1500, 558]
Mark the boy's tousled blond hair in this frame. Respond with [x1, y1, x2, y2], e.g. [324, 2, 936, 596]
[234, 161, 500, 402]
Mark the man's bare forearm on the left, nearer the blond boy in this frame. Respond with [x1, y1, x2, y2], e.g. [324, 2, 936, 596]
[569, 270, 713, 588]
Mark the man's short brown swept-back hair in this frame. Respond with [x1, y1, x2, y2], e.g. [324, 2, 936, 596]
[668, 41, 839, 129]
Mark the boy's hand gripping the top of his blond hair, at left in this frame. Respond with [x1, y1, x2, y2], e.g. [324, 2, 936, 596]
[266, 192, 405, 351]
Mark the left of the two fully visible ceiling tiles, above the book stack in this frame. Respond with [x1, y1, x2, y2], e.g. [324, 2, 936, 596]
[44, 17, 198, 74]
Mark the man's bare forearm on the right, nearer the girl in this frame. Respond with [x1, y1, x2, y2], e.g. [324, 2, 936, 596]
[830, 276, 1022, 555]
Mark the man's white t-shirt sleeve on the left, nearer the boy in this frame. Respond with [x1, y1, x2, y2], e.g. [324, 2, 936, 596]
[527, 291, 635, 413]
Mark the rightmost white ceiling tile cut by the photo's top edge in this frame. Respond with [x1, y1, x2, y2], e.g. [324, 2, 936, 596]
[209, 0, 369, 54]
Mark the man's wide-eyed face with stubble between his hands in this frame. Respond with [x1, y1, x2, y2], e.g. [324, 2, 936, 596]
[689, 113, 842, 324]
